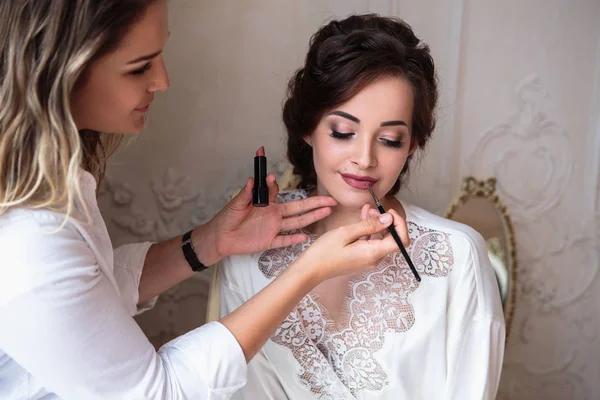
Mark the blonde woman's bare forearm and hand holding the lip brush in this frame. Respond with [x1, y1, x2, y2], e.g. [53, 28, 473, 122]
[221, 212, 408, 361]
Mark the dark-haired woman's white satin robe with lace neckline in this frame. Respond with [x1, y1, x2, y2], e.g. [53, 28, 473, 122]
[218, 191, 505, 400]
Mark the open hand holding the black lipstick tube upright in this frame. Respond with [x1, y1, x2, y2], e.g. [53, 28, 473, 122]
[199, 174, 337, 264]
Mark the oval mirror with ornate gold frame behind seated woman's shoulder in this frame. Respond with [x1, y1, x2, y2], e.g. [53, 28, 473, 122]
[444, 176, 517, 339]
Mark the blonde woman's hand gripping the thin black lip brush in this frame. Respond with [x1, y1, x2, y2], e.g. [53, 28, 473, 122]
[294, 209, 409, 285]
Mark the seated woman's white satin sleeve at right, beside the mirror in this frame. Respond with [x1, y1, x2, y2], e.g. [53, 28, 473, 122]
[444, 230, 506, 400]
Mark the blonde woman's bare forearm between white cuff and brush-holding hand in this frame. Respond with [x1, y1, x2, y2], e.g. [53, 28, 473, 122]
[220, 260, 316, 361]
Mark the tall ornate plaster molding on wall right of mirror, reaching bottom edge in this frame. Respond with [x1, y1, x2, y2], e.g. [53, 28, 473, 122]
[474, 75, 599, 399]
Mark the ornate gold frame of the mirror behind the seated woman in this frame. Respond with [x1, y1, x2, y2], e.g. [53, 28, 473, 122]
[444, 176, 517, 341]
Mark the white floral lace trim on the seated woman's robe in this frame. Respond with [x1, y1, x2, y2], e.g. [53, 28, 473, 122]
[258, 205, 454, 400]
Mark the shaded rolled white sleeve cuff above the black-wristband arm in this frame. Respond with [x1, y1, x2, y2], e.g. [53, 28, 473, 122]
[114, 242, 158, 315]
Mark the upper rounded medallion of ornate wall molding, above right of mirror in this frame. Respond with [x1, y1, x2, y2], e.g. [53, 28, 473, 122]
[468, 75, 573, 220]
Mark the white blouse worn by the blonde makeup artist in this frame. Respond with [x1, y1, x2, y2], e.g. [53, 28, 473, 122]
[0, 172, 247, 400]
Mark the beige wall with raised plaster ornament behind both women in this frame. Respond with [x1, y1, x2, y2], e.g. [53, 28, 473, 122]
[101, 0, 600, 399]
